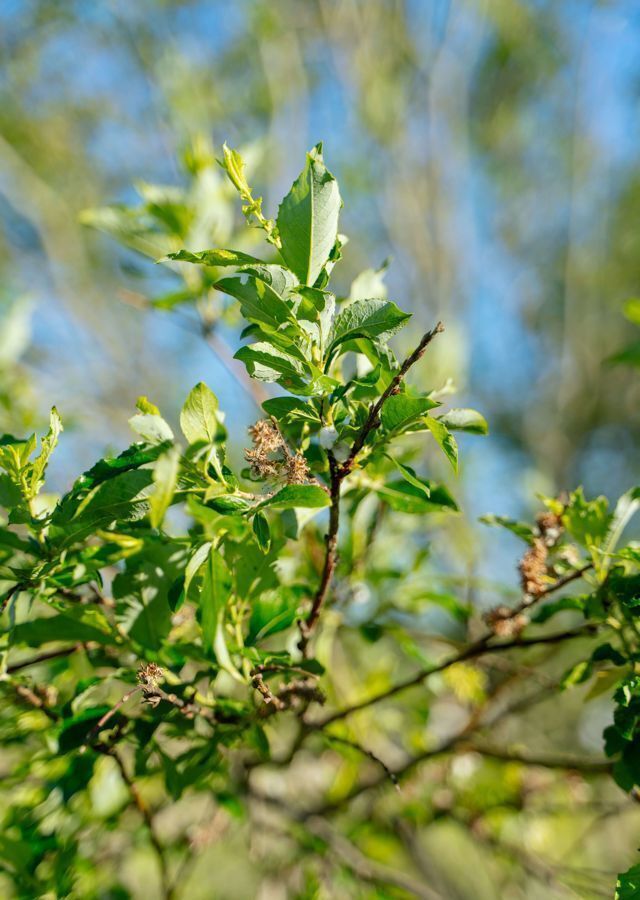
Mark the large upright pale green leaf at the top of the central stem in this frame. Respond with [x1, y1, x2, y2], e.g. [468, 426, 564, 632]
[277, 144, 342, 286]
